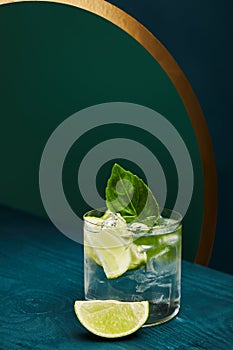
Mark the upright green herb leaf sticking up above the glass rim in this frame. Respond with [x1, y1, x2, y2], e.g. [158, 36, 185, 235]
[106, 164, 159, 223]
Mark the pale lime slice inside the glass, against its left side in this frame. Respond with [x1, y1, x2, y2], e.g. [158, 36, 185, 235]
[85, 231, 131, 279]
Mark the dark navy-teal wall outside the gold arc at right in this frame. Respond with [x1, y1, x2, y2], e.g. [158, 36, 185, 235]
[110, 0, 233, 273]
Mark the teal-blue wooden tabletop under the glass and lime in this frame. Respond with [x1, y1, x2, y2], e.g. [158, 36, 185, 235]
[0, 208, 233, 350]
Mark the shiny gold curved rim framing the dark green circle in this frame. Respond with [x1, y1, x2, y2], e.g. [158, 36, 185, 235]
[0, 0, 217, 265]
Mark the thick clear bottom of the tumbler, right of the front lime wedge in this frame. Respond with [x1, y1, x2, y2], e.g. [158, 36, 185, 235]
[142, 304, 180, 327]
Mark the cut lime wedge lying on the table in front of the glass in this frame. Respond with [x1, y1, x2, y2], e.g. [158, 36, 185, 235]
[74, 300, 149, 338]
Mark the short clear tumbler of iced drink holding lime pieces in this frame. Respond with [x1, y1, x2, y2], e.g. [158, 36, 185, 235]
[84, 209, 182, 326]
